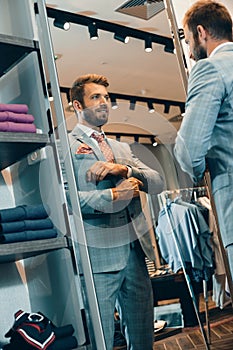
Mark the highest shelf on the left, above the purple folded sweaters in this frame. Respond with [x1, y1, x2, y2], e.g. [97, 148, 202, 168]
[0, 34, 38, 77]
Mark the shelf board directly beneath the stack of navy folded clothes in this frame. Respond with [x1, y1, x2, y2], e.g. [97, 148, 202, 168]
[0, 236, 68, 263]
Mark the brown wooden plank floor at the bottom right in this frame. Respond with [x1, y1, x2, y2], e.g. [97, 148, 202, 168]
[153, 298, 233, 350]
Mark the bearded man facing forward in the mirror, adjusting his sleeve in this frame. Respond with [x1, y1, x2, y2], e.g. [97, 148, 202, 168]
[69, 74, 163, 350]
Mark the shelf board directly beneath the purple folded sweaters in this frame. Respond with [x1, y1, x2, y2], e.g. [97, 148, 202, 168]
[0, 132, 49, 170]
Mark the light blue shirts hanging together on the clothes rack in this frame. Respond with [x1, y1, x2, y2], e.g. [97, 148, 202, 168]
[156, 199, 213, 277]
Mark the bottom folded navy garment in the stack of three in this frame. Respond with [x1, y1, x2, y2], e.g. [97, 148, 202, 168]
[0, 229, 57, 243]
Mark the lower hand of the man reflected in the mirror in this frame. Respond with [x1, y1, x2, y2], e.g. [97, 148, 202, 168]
[112, 177, 143, 200]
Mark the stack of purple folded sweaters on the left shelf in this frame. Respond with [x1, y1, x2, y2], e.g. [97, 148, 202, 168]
[0, 103, 36, 133]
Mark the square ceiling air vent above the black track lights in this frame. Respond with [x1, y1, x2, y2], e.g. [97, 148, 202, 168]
[116, 0, 165, 19]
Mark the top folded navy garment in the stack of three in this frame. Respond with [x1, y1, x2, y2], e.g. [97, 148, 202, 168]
[0, 204, 50, 222]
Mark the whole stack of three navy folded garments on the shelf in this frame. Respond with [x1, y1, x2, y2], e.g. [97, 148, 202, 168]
[0, 204, 57, 243]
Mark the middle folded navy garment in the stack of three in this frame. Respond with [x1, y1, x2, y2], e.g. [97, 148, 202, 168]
[0, 218, 53, 233]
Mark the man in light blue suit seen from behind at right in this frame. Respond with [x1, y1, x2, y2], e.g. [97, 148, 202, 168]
[174, 0, 233, 283]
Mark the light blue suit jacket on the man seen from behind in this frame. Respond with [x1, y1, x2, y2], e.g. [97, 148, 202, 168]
[174, 43, 233, 246]
